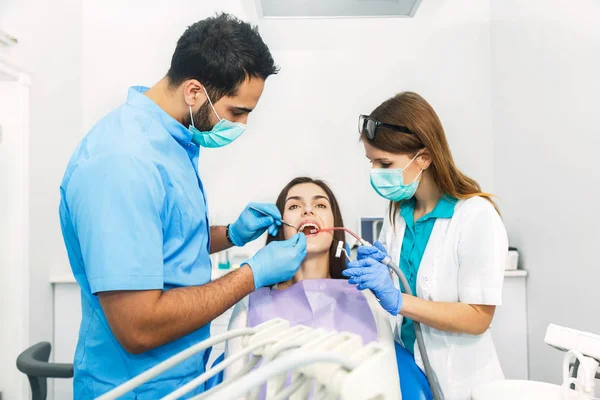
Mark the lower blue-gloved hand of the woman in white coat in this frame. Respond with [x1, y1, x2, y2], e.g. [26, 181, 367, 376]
[342, 258, 402, 316]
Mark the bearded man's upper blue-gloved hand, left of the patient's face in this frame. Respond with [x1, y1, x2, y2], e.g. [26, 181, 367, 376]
[229, 203, 281, 246]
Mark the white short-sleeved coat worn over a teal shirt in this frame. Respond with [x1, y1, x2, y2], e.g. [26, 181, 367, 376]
[379, 197, 508, 400]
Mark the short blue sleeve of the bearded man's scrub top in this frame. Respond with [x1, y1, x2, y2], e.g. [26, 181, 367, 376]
[66, 154, 165, 294]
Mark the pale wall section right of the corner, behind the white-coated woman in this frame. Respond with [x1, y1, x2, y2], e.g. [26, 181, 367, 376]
[492, 0, 600, 383]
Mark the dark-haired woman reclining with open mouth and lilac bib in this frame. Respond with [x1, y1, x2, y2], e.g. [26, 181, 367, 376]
[225, 177, 412, 397]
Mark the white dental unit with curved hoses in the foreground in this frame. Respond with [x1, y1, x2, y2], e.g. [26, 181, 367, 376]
[97, 318, 398, 400]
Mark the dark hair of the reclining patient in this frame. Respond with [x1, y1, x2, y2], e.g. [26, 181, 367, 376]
[267, 177, 348, 279]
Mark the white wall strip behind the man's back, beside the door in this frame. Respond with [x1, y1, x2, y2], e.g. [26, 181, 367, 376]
[0, 0, 82, 390]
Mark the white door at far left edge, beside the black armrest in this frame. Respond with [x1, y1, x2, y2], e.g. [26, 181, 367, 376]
[0, 79, 30, 399]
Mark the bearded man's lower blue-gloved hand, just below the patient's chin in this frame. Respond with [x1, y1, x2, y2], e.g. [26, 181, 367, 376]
[244, 233, 306, 289]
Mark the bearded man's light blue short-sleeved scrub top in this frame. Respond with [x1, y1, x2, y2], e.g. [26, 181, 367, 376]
[60, 87, 211, 399]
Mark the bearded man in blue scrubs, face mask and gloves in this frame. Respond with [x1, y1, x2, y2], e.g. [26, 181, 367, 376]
[60, 14, 306, 399]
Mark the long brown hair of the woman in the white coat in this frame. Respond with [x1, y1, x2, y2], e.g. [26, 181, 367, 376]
[360, 92, 500, 223]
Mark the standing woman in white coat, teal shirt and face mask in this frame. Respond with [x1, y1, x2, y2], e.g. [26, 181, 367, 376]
[343, 92, 508, 400]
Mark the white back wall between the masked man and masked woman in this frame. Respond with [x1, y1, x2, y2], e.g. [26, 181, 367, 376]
[77, 0, 493, 262]
